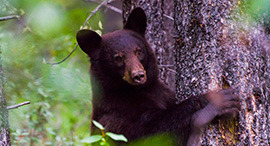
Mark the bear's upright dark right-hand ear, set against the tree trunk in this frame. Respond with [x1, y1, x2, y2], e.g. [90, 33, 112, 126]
[124, 7, 146, 35]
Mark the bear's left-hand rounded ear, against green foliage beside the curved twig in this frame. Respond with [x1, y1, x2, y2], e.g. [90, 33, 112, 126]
[76, 29, 102, 58]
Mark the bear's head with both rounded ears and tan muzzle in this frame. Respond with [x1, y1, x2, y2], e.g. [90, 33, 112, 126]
[77, 8, 158, 86]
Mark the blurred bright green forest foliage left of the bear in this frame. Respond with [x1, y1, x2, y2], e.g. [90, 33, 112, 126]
[0, 0, 103, 145]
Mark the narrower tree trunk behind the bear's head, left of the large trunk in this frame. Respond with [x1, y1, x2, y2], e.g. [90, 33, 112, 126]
[123, 0, 175, 89]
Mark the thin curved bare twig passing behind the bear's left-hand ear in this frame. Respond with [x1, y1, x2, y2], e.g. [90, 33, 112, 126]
[46, 0, 113, 65]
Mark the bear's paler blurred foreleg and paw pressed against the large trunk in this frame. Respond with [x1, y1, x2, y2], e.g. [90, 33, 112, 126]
[188, 88, 240, 146]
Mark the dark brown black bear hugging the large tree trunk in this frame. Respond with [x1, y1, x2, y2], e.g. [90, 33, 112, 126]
[77, 8, 239, 145]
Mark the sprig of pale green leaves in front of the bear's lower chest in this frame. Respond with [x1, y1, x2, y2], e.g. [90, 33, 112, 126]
[81, 120, 128, 146]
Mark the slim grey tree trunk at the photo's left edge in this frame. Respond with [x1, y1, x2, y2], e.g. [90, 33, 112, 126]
[0, 49, 11, 146]
